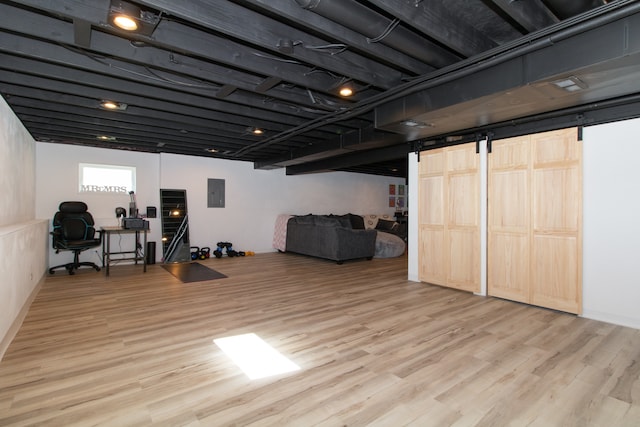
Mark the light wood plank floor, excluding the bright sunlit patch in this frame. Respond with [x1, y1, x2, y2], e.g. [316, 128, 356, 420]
[0, 253, 640, 427]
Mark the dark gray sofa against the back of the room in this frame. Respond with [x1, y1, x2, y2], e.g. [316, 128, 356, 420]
[286, 215, 377, 264]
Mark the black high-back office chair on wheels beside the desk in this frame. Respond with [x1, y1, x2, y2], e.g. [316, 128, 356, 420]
[49, 202, 102, 274]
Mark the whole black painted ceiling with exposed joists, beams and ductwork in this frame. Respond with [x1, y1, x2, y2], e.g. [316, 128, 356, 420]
[0, 0, 640, 177]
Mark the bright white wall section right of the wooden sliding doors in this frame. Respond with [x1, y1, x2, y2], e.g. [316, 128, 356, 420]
[582, 119, 640, 328]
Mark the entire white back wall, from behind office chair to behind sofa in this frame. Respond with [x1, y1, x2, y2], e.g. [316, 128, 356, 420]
[36, 147, 404, 265]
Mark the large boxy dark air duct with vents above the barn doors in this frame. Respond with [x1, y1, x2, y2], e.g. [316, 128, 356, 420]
[375, 7, 640, 140]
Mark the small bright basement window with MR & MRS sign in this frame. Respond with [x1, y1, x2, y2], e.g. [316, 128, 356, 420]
[78, 163, 136, 194]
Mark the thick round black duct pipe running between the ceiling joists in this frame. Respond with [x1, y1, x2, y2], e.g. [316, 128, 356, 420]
[296, 0, 461, 68]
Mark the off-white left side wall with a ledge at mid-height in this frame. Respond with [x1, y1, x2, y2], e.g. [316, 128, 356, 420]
[0, 97, 48, 358]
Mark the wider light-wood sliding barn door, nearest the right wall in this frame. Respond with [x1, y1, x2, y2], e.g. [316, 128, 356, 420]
[487, 128, 582, 313]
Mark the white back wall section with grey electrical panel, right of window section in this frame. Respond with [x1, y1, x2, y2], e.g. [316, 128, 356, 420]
[161, 154, 404, 252]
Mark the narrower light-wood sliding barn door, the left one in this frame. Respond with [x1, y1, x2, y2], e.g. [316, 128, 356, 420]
[418, 143, 480, 292]
